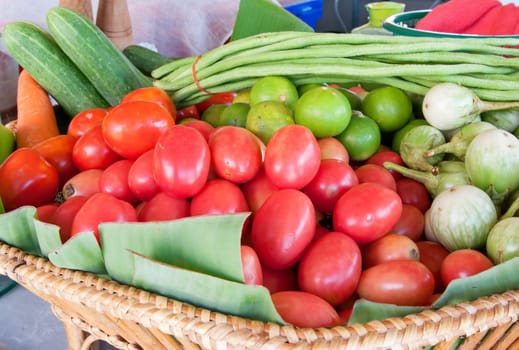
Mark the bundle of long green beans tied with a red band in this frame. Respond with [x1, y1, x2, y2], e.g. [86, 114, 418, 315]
[152, 32, 519, 106]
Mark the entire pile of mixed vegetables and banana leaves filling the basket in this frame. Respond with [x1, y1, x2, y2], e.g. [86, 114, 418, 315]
[0, 8, 519, 346]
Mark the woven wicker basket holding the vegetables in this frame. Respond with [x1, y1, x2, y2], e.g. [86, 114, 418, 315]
[0, 243, 519, 350]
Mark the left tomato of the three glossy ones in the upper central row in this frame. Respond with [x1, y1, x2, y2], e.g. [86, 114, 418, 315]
[153, 125, 211, 198]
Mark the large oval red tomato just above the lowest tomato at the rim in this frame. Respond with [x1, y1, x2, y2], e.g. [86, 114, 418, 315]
[298, 232, 362, 306]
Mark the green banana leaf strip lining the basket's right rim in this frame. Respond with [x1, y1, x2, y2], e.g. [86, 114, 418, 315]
[348, 257, 519, 324]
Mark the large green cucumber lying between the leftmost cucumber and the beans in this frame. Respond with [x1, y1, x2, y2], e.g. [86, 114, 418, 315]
[46, 7, 151, 106]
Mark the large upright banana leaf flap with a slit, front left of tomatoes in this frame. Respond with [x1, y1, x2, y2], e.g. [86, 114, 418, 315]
[99, 213, 250, 284]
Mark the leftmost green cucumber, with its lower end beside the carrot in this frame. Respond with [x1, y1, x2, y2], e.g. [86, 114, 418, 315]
[2, 21, 109, 117]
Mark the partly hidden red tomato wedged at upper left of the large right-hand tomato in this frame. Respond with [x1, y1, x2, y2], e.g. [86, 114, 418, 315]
[303, 159, 359, 214]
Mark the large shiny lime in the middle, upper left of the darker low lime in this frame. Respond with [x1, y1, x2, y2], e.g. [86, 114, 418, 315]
[294, 86, 351, 138]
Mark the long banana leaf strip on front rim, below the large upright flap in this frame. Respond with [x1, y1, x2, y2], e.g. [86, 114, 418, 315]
[131, 252, 284, 324]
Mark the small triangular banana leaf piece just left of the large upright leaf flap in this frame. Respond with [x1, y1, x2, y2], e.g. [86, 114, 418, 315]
[48, 231, 107, 277]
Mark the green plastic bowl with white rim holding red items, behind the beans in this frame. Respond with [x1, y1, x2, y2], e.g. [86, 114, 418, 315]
[382, 10, 519, 38]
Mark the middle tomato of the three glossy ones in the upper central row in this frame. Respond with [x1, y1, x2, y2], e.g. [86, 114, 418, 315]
[208, 125, 261, 183]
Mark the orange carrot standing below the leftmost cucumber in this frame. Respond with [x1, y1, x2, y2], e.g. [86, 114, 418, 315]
[15, 70, 59, 148]
